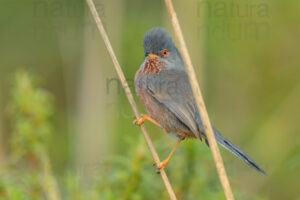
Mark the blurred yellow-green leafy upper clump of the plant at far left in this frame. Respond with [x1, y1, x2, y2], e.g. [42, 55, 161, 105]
[11, 71, 53, 164]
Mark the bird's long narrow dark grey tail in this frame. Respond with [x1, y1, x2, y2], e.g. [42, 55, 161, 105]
[206, 127, 266, 174]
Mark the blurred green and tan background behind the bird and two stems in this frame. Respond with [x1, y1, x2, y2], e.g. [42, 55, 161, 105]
[0, 0, 300, 199]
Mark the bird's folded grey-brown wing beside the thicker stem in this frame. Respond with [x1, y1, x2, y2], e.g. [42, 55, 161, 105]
[147, 70, 200, 137]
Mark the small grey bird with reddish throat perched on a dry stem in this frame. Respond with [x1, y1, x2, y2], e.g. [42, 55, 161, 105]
[133, 28, 265, 174]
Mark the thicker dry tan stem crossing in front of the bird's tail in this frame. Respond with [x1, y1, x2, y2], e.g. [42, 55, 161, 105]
[165, 0, 234, 200]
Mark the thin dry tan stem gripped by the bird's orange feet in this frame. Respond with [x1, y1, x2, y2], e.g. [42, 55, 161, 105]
[86, 0, 176, 200]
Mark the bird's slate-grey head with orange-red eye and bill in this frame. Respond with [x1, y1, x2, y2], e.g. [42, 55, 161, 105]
[143, 28, 182, 67]
